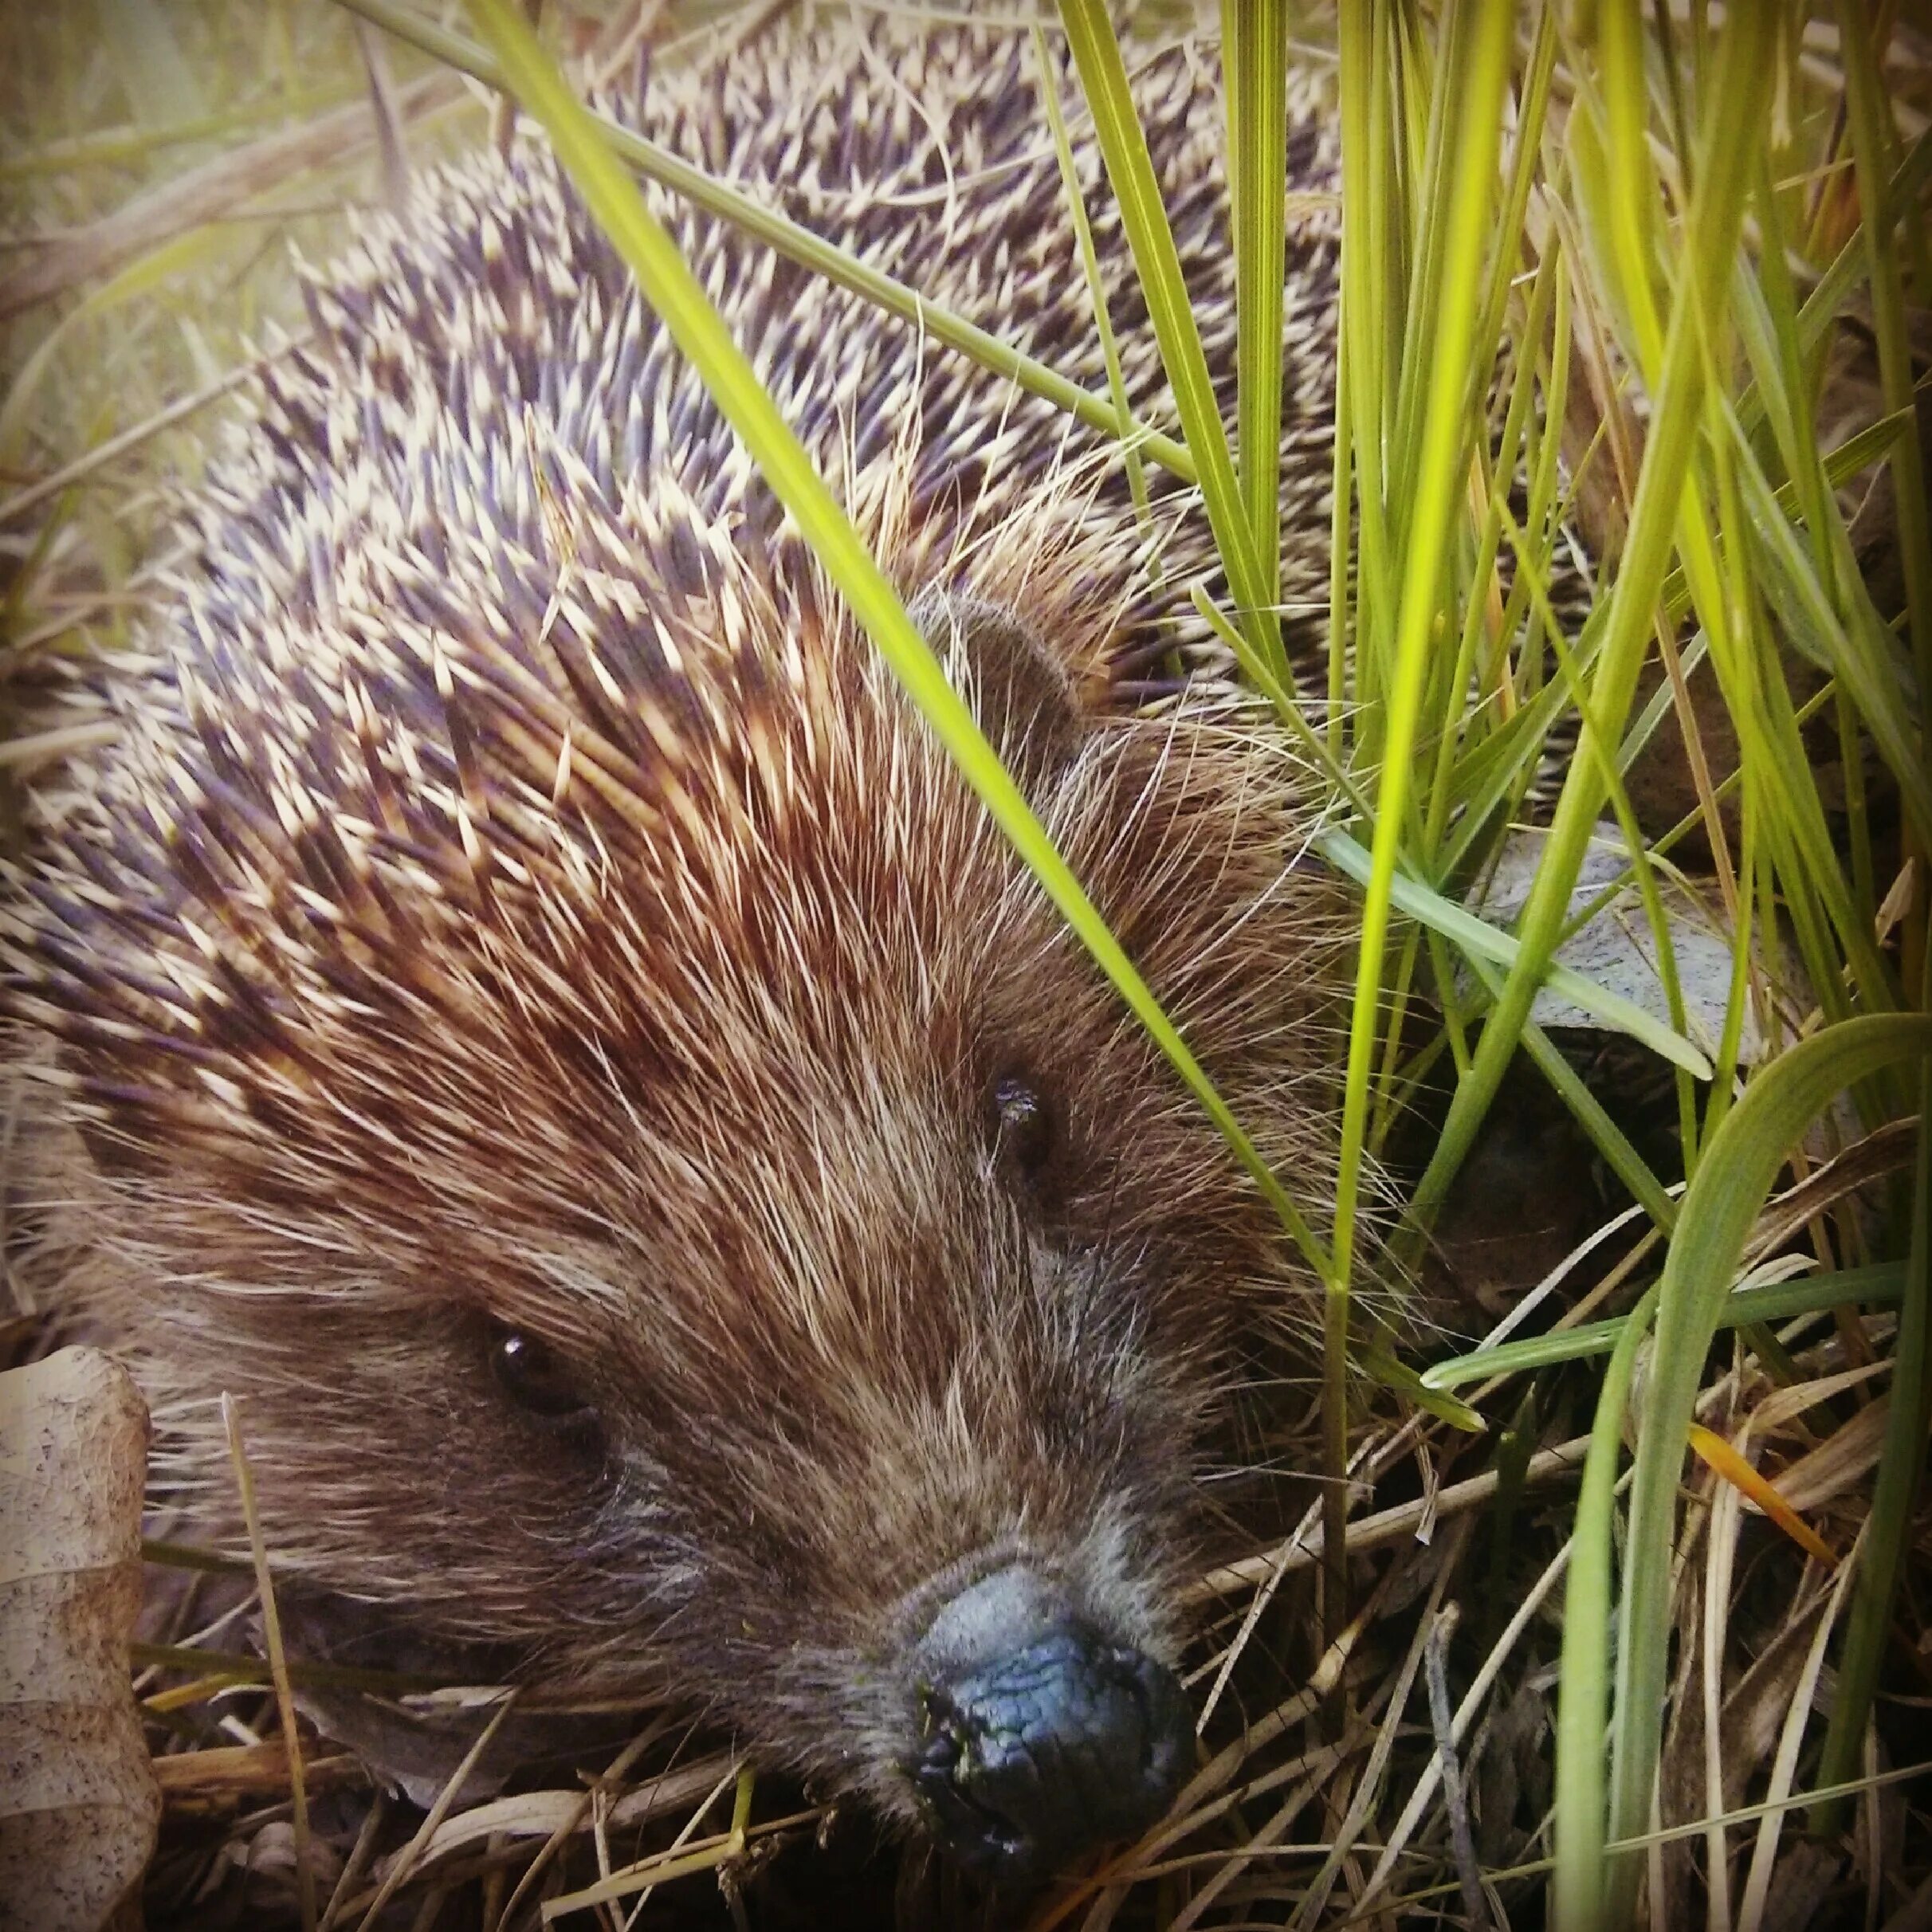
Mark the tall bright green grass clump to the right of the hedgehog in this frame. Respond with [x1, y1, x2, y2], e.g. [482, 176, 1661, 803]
[1306, 4, 1932, 1926]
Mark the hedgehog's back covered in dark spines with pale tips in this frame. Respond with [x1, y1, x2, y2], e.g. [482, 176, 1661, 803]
[14, 18, 1333, 1190]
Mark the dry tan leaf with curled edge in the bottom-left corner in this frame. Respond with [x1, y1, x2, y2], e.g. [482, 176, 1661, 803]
[0, 1349, 160, 1932]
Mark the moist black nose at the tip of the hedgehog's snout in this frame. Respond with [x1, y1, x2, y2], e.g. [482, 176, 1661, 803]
[908, 1571, 1194, 1883]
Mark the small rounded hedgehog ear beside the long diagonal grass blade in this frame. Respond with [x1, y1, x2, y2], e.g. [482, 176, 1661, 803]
[906, 583, 1086, 792]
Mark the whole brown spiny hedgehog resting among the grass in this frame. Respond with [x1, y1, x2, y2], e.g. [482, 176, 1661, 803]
[0, 22, 1347, 1883]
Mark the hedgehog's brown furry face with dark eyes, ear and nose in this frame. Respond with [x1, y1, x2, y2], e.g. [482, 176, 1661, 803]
[18, 540, 1327, 1876]
